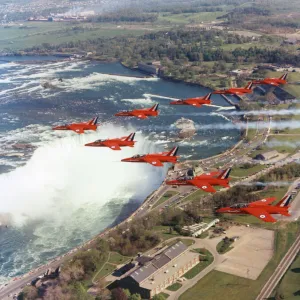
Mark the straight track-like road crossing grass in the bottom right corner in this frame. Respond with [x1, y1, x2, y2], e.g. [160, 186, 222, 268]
[256, 234, 300, 300]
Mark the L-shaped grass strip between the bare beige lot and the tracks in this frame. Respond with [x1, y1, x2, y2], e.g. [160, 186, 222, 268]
[179, 222, 300, 300]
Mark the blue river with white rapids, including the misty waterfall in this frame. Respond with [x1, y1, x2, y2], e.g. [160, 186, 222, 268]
[0, 57, 239, 283]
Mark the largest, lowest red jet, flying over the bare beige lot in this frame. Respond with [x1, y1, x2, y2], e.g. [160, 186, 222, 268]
[216, 194, 292, 222]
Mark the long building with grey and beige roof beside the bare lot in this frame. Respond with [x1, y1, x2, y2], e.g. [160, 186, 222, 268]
[117, 241, 200, 299]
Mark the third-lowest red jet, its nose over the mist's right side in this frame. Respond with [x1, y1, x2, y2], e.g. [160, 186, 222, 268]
[122, 147, 178, 167]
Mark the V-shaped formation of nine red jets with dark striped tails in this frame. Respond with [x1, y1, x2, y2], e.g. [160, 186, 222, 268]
[52, 73, 291, 222]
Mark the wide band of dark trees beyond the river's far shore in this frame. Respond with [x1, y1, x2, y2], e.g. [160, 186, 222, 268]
[26, 29, 300, 88]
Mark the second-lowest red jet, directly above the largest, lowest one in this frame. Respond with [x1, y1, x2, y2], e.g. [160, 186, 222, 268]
[166, 168, 231, 193]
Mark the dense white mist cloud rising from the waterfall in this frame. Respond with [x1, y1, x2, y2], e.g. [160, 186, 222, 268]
[0, 125, 164, 226]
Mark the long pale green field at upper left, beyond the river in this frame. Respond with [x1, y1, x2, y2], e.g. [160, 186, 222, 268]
[0, 22, 159, 50]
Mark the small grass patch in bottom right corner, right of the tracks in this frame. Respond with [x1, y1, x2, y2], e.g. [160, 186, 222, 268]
[276, 253, 300, 300]
